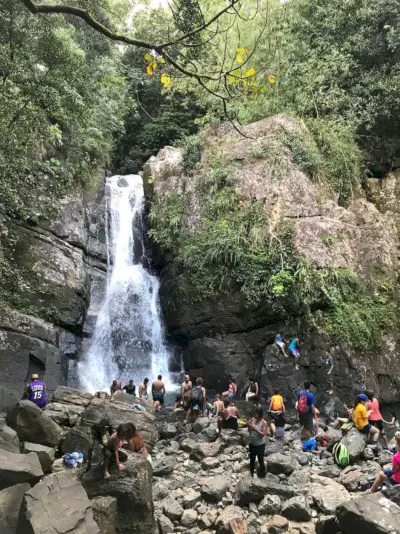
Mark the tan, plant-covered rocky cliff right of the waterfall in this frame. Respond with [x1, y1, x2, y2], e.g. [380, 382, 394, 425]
[144, 117, 400, 402]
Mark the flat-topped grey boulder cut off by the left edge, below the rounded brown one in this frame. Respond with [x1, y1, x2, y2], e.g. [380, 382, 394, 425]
[0, 450, 43, 489]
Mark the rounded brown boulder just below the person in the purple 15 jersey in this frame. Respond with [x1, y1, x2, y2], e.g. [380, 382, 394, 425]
[6, 400, 63, 447]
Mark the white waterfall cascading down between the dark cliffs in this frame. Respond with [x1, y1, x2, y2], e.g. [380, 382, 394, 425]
[79, 175, 170, 392]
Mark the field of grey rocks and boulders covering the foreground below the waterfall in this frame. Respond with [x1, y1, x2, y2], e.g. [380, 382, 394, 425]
[0, 387, 400, 534]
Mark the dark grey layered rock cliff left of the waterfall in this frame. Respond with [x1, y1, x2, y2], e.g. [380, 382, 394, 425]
[0, 176, 107, 408]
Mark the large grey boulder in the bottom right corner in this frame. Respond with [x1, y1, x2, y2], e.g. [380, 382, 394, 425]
[336, 493, 400, 534]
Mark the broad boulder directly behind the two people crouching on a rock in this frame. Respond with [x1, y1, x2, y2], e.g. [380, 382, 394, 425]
[79, 395, 158, 452]
